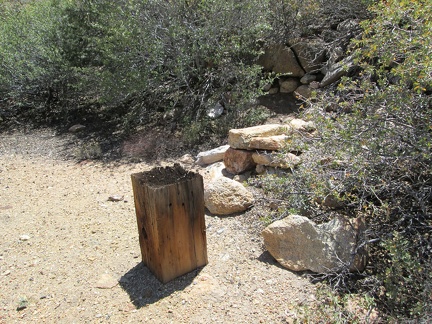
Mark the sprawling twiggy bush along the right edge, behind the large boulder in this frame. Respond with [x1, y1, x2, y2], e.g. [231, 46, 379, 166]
[253, 0, 432, 321]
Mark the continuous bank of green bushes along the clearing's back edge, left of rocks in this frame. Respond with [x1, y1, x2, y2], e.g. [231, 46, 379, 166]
[0, 0, 269, 138]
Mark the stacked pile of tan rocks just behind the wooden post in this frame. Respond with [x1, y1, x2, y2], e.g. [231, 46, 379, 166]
[196, 119, 315, 215]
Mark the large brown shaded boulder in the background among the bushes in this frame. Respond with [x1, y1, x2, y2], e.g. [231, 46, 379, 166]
[258, 44, 305, 78]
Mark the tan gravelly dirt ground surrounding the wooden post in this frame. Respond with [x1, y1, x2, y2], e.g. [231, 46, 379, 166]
[0, 130, 315, 323]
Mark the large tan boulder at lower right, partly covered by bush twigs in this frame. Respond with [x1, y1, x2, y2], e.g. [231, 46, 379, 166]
[262, 215, 367, 273]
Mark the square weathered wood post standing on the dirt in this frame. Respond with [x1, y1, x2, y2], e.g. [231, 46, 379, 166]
[131, 164, 208, 283]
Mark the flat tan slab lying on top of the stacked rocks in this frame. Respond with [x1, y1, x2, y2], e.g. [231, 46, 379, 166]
[228, 124, 288, 150]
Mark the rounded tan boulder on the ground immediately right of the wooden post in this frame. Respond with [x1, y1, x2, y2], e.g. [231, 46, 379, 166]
[204, 177, 254, 215]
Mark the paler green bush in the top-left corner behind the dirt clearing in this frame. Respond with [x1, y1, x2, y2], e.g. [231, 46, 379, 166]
[0, 0, 66, 119]
